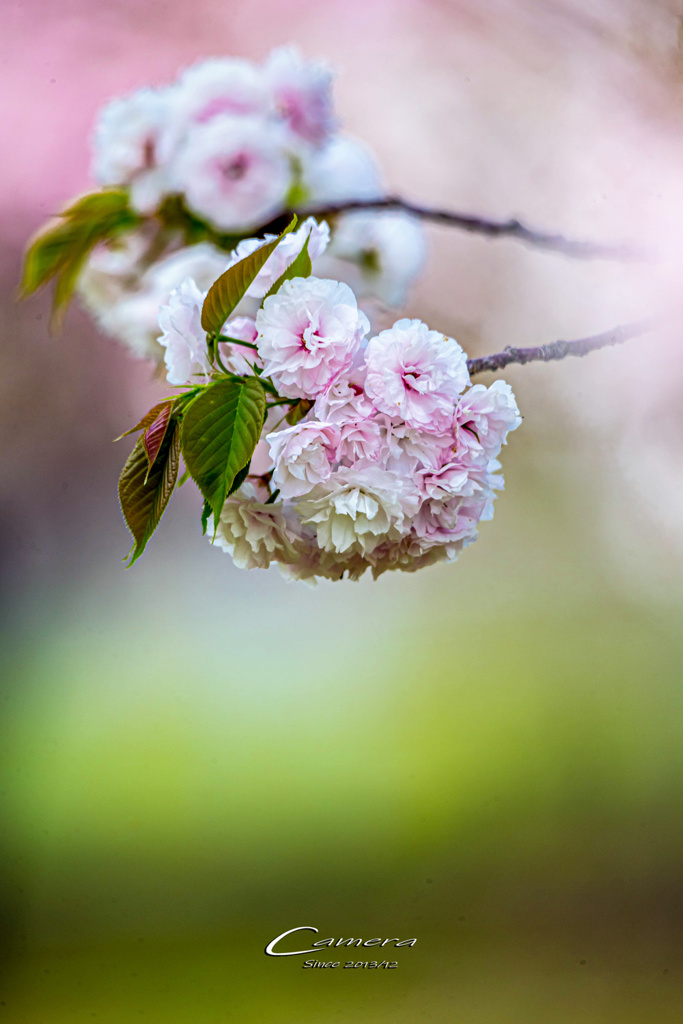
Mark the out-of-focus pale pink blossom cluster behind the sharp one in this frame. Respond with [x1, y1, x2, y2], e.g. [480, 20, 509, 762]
[78, 47, 425, 359]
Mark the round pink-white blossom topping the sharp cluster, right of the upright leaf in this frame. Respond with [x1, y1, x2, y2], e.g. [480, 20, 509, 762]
[256, 278, 370, 398]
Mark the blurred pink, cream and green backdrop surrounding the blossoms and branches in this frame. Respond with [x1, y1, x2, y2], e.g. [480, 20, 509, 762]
[0, 0, 683, 1024]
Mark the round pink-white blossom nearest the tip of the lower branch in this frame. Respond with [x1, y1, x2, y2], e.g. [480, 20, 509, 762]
[366, 319, 469, 433]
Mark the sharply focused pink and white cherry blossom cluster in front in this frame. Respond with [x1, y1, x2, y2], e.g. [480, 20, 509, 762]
[159, 219, 521, 580]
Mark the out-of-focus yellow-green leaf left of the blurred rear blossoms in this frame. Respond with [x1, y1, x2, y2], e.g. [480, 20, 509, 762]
[19, 188, 141, 325]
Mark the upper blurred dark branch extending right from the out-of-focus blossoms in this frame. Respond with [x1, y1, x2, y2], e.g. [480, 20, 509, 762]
[290, 196, 652, 263]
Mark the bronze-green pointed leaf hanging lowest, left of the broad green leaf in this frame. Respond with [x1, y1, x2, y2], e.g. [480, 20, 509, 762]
[119, 422, 180, 567]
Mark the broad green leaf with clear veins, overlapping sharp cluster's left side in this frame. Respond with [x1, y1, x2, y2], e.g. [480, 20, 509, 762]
[182, 377, 265, 523]
